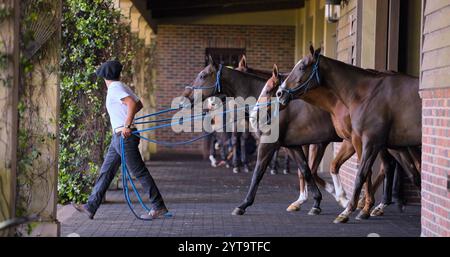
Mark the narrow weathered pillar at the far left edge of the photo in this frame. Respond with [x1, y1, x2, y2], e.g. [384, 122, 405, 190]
[0, 0, 19, 236]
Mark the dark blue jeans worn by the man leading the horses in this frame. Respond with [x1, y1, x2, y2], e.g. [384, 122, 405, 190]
[87, 131, 165, 213]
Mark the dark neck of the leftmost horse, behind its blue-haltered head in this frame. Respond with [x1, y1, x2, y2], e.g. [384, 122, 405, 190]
[221, 68, 265, 98]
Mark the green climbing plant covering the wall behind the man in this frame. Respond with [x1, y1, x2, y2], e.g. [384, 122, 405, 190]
[58, 0, 134, 203]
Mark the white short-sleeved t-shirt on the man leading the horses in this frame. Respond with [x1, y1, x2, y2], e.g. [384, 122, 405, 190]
[106, 81, 139, 131]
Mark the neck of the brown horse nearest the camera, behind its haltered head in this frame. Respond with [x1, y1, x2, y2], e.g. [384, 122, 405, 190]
[319, 56, 379, 107]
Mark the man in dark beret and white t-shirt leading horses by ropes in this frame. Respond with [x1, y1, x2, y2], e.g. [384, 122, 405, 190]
[73, 61, 168, 219]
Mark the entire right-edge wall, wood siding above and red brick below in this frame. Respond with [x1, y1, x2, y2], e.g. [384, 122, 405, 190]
[420, 0, 450, 237]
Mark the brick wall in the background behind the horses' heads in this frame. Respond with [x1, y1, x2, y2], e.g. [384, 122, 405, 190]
[156, 25, 295, 153]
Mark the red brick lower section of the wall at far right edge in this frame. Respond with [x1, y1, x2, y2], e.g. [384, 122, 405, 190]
[421, 88, 450, 237]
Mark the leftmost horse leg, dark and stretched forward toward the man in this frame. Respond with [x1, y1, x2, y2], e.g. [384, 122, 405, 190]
[232, 144, 279, 215]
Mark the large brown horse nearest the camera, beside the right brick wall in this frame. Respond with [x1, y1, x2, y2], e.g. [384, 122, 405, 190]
[277, 47, 421, 223]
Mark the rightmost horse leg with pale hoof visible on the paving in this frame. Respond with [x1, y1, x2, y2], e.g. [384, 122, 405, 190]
[370, 150, 396, 216]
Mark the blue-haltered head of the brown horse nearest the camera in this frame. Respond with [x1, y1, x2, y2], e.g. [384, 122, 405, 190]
[276, 45, 322, 105]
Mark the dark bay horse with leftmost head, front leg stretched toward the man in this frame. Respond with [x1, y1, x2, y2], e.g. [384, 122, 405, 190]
[179, 57, 342, 215]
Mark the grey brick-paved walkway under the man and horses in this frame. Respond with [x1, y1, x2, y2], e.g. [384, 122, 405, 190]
[61, 158, 420, 237]
